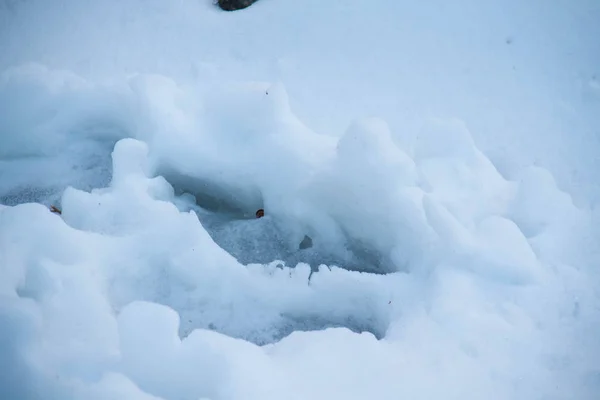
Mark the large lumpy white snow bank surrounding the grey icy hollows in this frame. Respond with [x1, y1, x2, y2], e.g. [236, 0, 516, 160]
[0, 64, 595, 399]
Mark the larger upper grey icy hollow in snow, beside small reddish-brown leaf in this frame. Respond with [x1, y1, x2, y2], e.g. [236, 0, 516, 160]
[160, 170, 395, 274]
